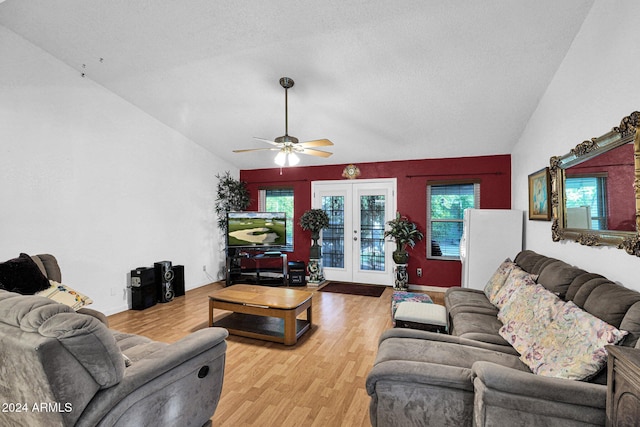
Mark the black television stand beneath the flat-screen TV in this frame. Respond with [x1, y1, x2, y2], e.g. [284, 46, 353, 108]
[226, 250, 288, 286]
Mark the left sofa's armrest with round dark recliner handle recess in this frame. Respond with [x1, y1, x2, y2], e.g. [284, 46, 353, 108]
[78, 328, 228, 426]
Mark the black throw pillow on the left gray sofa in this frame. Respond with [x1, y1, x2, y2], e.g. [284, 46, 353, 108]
[0, 253, 49, 295]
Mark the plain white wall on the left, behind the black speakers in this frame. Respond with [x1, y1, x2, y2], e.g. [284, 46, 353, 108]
[0, 26, 239, 314]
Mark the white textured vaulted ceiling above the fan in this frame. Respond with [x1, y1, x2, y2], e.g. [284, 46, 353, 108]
[0, 0, 593, 169]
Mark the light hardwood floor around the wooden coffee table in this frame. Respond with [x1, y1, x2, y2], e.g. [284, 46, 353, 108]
[109, 282, 442, 427]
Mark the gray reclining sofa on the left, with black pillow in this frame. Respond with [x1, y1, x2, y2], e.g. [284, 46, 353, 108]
[0, 255, 227, 427]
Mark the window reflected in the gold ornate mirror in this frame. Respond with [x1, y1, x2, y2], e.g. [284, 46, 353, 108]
[565, 175, 608, 230]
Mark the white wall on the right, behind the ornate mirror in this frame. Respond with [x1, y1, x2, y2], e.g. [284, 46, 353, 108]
[505, 0, 640, 290]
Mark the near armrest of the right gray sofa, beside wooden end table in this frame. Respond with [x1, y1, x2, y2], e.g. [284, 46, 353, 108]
[471, 362, 607, 426]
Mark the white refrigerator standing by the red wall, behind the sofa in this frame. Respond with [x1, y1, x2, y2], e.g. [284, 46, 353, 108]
[460, 209, 524, 289]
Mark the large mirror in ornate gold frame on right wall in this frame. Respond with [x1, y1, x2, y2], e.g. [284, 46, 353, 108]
[550, 111, 640, 257]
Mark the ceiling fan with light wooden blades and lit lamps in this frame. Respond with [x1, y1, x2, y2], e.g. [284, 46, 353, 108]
[233, 77, 333, 166]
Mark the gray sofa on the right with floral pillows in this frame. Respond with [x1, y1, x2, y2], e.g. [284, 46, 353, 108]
[366, 251, 640, 426]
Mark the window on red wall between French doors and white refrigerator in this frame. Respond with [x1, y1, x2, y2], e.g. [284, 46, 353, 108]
[427, 182, 480, 260]
